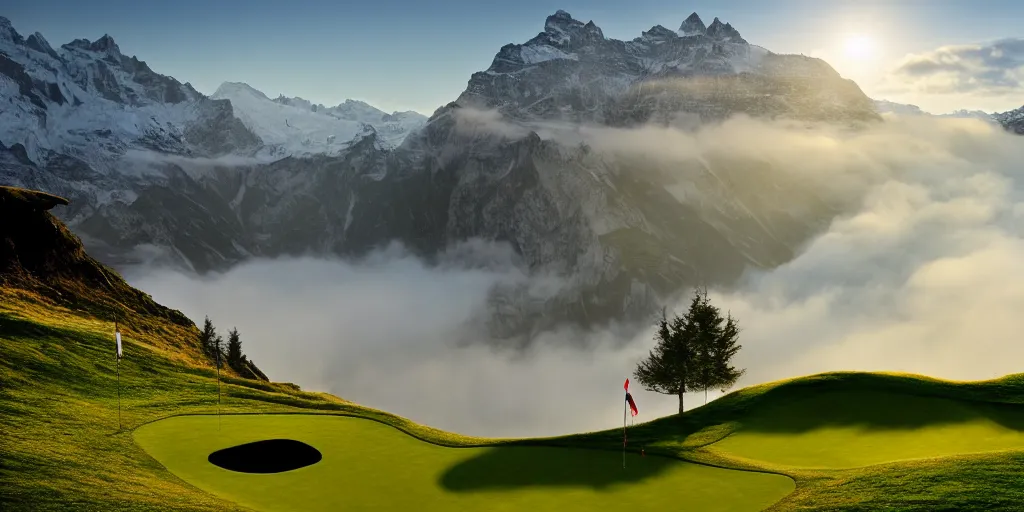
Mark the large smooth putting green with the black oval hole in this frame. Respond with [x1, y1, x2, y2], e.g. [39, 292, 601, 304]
[134, 415, 795, 511]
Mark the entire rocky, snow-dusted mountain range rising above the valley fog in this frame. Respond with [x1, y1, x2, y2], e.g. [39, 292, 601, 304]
[0, 10, 1017, 336]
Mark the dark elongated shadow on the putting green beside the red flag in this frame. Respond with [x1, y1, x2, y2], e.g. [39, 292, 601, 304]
[439, 446, 671, 493]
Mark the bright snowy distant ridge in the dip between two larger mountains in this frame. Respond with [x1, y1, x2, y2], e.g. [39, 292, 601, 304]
[211, 82, 427, 156]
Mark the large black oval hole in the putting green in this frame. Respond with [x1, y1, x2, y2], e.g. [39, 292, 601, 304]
[207, 439, 324, 473]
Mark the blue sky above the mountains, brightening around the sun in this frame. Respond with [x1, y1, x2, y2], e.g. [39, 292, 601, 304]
[0, 0, 1024, 114]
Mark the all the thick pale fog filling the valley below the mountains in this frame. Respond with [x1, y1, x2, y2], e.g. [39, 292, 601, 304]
[123, 117, 1024, 436]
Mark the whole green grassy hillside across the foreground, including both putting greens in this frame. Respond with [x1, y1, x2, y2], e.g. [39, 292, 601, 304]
[0, 187, 1024, 511]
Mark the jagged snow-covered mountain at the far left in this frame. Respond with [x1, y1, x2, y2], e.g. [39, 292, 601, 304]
[0, 17, 261, 228]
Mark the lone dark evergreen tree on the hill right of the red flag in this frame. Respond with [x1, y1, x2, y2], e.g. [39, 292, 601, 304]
[633, 291, 743, 414]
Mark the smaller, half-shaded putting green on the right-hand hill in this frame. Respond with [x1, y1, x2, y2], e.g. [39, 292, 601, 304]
[712, 392, 1024, 468]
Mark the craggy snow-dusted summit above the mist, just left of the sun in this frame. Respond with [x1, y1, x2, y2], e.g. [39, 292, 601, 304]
[458, 10, 879, 125]
